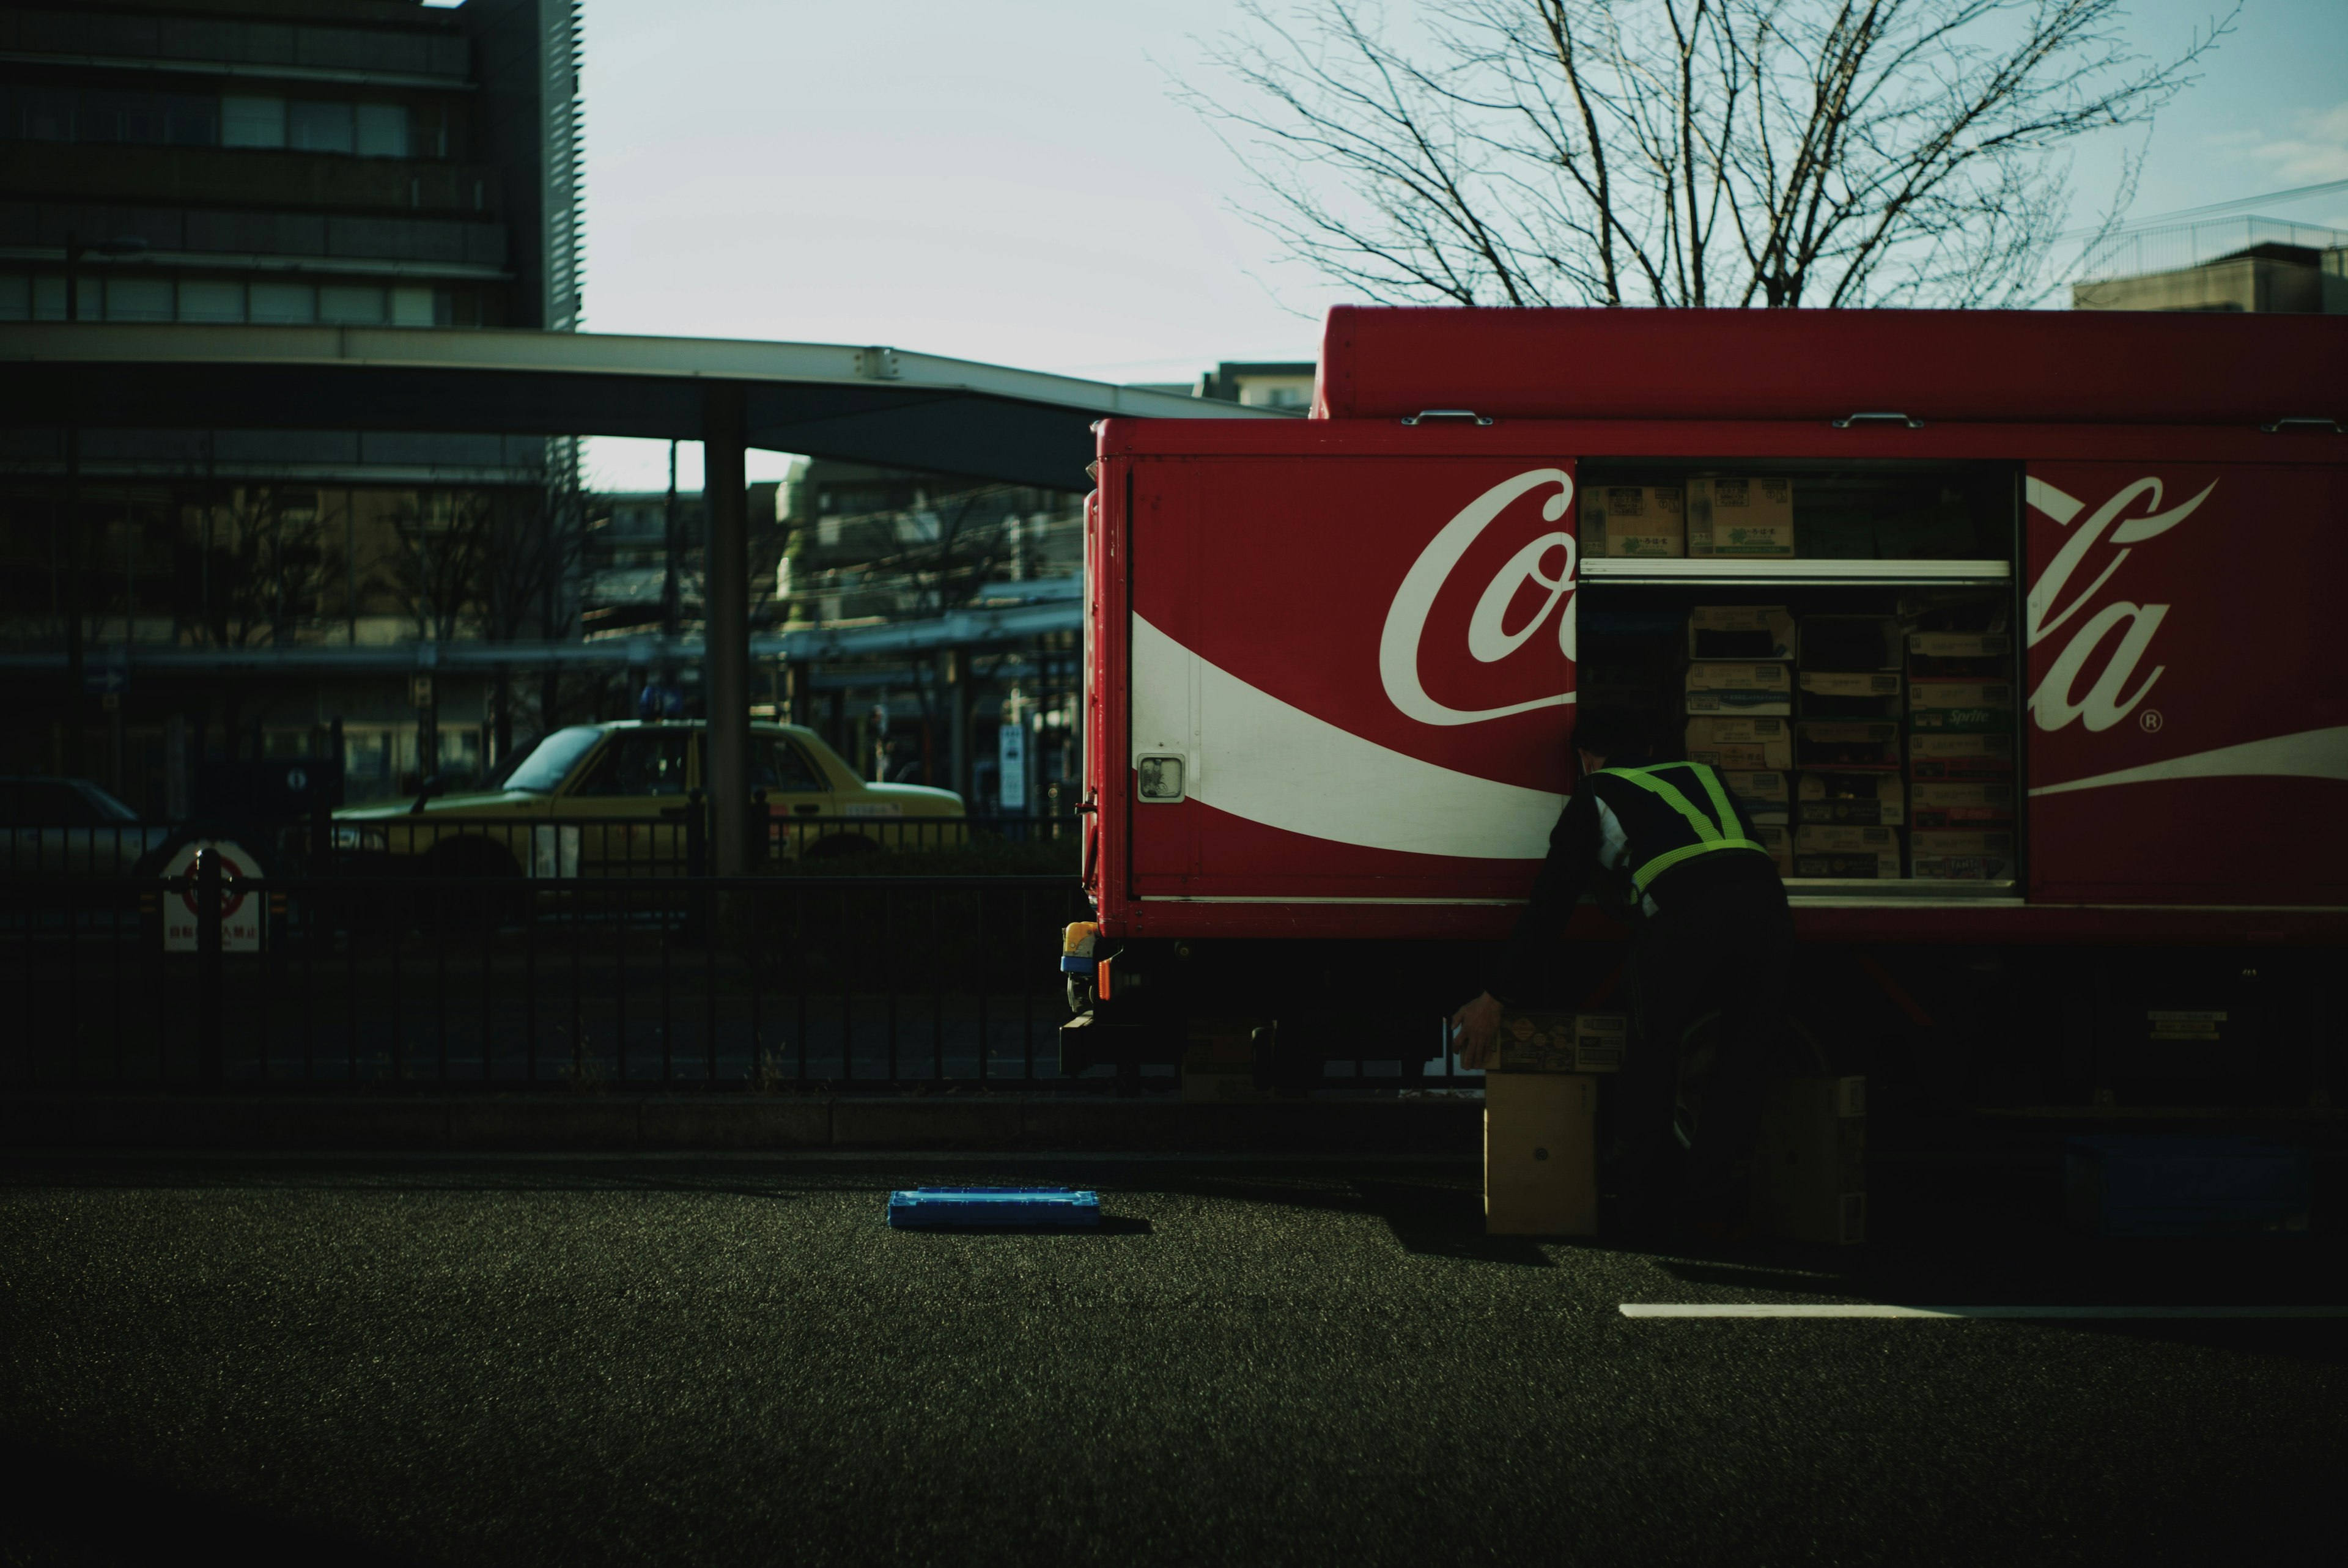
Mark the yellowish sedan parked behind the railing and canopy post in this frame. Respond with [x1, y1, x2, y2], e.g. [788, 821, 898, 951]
[333, 723, 962, 875]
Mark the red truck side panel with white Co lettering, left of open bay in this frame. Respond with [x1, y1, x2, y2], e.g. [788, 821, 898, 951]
[1104, 425, 1578, 934]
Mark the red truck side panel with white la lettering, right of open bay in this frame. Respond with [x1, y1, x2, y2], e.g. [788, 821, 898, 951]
[2026, 455, 2348, 906]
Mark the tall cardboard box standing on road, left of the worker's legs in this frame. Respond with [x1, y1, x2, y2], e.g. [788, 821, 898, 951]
[1484, 1073, 1599, 1237]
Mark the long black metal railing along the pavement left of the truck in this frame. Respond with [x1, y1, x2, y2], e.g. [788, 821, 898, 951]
[0, 861, 1085, 1089]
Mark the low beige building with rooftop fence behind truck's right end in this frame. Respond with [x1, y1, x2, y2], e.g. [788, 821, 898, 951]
[2071, 218, 2348, 315]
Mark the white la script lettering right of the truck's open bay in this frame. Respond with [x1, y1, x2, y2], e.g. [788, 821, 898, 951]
[2026, 476, 2217, 730]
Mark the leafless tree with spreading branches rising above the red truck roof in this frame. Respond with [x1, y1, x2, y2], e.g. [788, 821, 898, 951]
[1183, 0, 2240, 305]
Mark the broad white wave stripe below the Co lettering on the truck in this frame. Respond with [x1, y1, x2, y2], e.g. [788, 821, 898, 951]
[1132, 615, 1566, 859]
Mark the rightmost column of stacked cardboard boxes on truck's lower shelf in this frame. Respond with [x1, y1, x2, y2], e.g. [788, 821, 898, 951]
[1907, 631, 2017, 883]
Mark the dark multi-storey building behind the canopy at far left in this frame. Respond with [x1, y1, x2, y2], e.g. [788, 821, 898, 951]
[0, 0, 585, 812]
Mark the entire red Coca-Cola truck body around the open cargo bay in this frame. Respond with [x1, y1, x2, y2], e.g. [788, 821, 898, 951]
[1085, 310, 2348, 946]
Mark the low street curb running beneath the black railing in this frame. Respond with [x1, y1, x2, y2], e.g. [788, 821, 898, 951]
[0, 1094, 1484, 1160]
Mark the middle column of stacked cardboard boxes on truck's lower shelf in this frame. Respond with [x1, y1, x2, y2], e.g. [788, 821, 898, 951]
[1794, 615, 1907, 880]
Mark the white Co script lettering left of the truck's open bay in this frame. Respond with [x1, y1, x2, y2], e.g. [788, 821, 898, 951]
[1378, 467, 1578, 726]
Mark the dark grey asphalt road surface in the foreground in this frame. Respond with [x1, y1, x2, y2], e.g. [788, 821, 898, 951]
[0, 1157, 2348, 1563]
